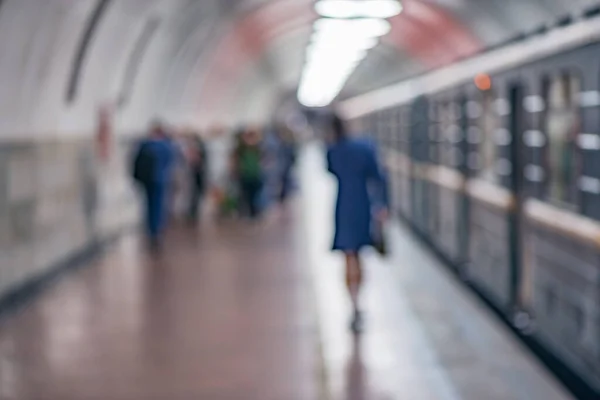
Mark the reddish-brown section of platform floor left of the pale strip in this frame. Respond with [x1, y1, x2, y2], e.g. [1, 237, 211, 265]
[0, 212, 318, 400]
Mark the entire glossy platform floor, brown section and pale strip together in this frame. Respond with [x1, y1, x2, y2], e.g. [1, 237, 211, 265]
[0, 148, 570, 400]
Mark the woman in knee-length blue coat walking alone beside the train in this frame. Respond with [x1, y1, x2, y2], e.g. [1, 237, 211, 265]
[327, 116, 387, 333]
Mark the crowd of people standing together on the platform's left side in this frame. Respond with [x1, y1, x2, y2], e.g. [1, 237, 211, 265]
[132, 122, 296, 248]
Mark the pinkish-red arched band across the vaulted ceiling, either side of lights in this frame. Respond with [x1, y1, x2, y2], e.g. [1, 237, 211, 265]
[198, 0, 482, 118]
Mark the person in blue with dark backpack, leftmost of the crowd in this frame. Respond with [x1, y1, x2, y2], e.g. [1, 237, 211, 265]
[133, 122, 176, 249]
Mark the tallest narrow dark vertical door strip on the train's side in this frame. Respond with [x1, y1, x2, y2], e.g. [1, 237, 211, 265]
[509, 83, 525, 310]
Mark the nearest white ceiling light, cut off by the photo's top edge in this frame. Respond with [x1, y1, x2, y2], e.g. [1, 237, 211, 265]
[315, 0, 402, 19]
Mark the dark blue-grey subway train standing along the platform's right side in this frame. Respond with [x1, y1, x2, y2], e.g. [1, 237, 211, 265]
[339, 10, 600, 398]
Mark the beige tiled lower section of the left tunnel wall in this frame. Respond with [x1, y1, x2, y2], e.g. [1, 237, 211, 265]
[0, 139, 139, 300]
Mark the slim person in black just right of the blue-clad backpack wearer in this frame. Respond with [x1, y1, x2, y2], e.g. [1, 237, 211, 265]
[188, 135, 208, 225]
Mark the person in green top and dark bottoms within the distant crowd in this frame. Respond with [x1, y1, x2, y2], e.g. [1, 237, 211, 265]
[235, 129, 263, 219]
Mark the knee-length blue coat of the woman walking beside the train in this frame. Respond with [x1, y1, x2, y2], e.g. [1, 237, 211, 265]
[327, 139, 387, 252]
